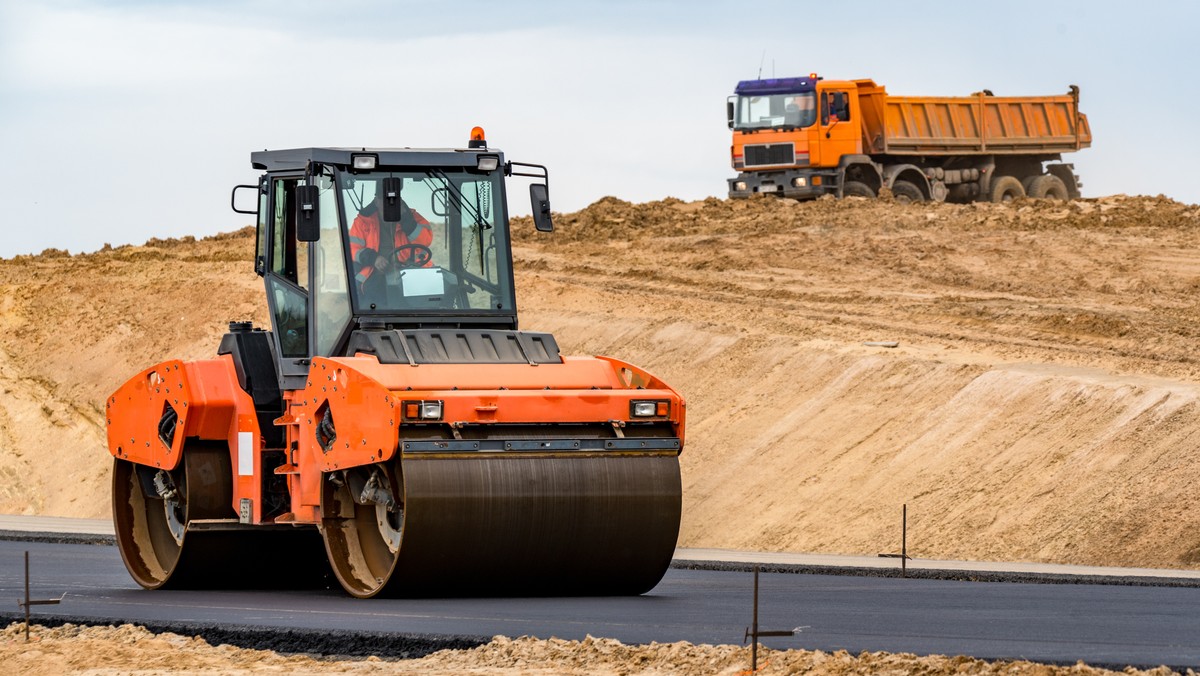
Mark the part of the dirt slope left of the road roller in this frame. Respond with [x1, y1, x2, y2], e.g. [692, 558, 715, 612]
[0, 232, 266, 516]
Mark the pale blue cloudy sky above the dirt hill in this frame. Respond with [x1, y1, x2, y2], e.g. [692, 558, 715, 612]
[0, 0, 1200, 257]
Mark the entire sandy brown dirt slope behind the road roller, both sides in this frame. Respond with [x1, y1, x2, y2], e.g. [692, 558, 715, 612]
[0, 197, 1200, 567]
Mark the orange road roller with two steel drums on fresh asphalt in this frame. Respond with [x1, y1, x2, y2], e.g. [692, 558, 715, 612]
[106, 127, 685, 598]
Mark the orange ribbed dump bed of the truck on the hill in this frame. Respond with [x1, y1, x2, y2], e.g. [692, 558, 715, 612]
[854, 80, 1092, 155]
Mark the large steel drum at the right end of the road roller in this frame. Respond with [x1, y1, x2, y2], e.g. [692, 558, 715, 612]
[322, 453, 682, 598]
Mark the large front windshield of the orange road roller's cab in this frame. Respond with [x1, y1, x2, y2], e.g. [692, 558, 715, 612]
[338, 169, 514, 315]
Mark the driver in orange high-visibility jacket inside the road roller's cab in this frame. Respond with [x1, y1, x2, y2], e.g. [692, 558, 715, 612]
[349, 195, 433, 297]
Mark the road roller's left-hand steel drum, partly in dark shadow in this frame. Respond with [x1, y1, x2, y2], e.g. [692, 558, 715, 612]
[113, 443, 329, 590]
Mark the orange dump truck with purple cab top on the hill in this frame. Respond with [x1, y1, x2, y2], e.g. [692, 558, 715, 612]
[726, 73, 1092, 203]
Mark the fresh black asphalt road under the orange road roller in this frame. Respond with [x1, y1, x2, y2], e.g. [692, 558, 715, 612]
[0, 542, 1200, 668]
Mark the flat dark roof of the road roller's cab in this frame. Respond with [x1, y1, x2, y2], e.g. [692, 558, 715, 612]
[250, 148, 503, 172]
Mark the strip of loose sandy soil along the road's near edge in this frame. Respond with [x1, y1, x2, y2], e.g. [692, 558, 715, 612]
[0, 624, 1192, 676]
